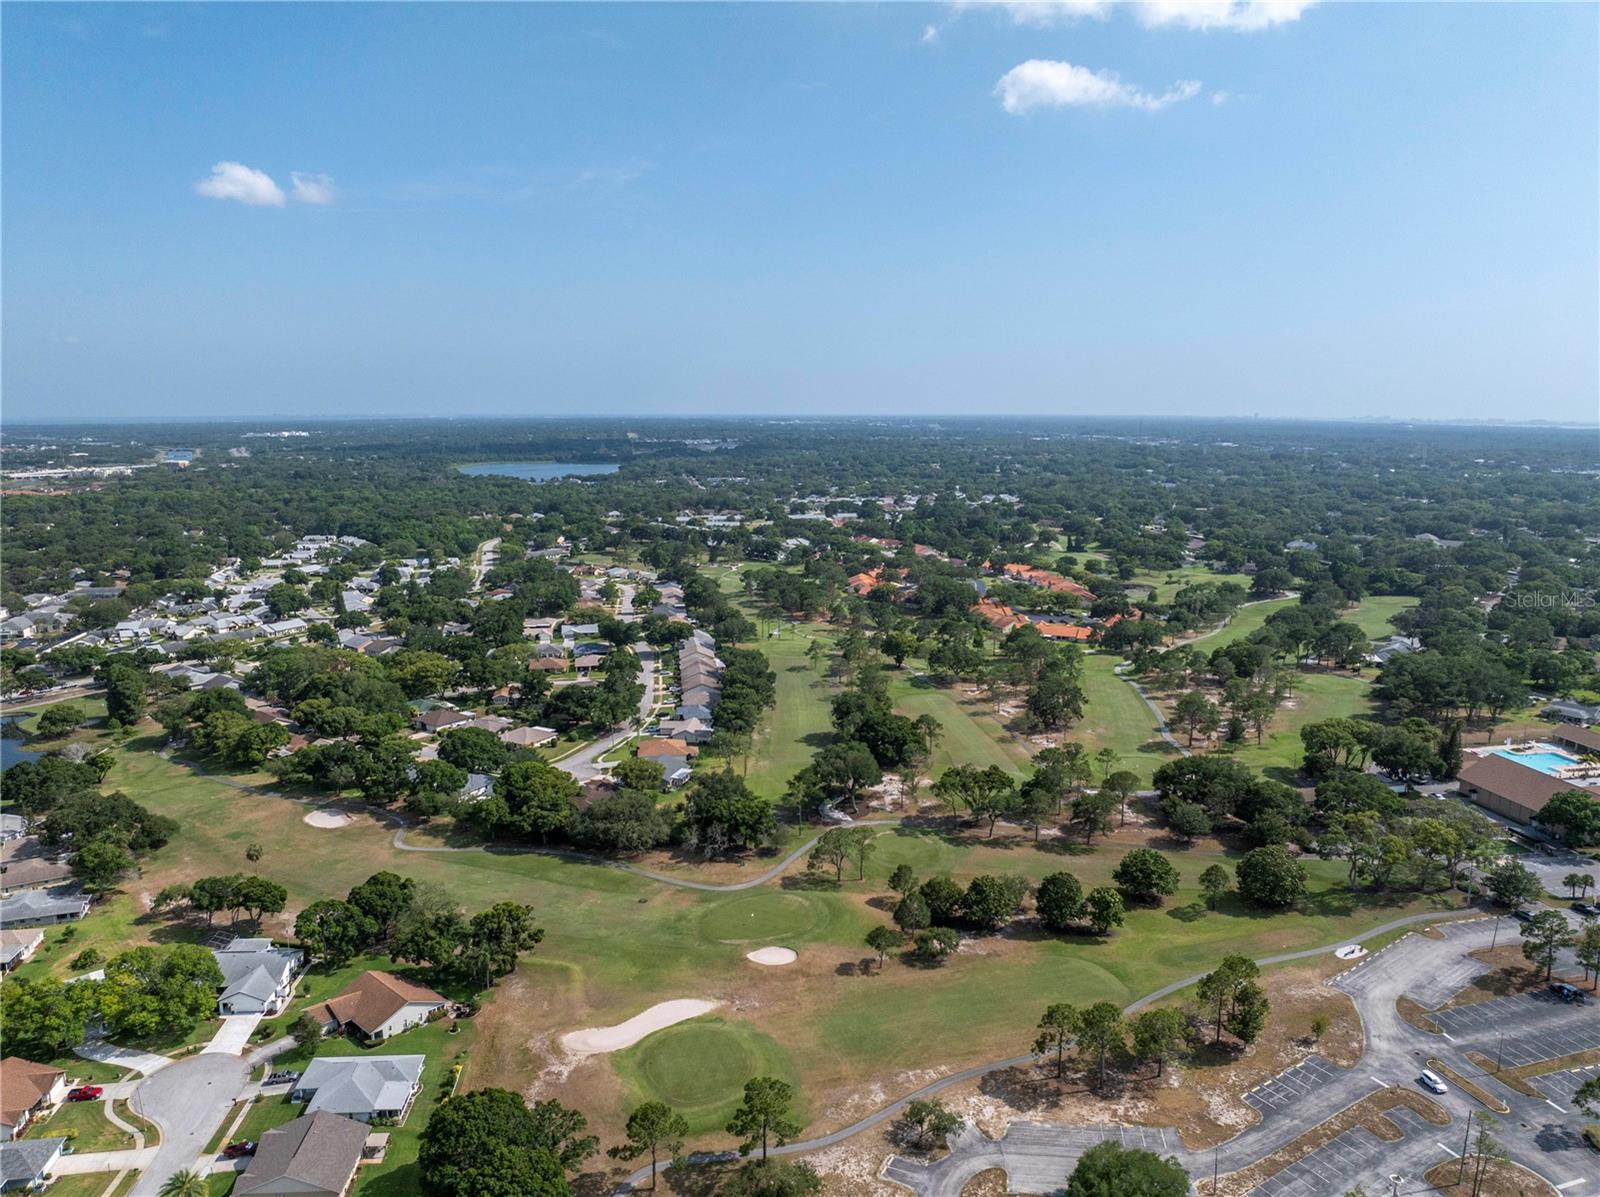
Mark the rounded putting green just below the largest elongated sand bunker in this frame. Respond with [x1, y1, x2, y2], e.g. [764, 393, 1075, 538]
[614, 1018, 795, 1133]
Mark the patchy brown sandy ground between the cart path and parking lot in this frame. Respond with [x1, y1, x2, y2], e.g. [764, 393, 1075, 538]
[944, 960, 1363, 1151]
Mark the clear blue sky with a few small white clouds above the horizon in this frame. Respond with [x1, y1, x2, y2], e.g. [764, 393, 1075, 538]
[3, 0, 1600, 421]
